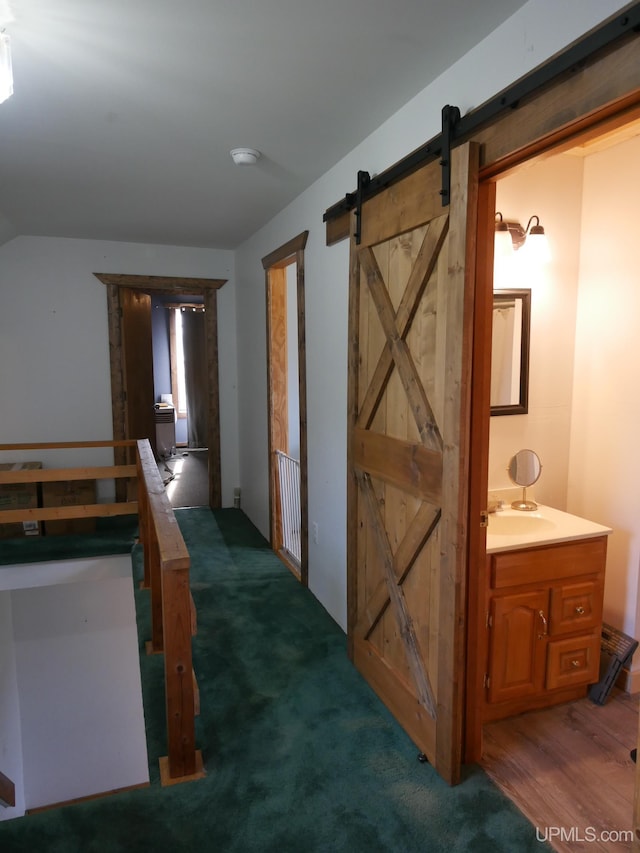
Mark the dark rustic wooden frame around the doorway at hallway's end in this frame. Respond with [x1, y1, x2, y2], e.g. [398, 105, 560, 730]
[94, 273, 227, 509]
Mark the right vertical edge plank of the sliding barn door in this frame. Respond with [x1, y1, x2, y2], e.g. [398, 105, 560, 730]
[436, 143, 479, 781]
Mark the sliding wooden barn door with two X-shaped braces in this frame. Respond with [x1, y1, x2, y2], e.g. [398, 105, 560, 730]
[348, 145, 477, 784]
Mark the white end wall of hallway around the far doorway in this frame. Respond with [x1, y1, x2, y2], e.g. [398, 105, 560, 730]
[0, 237, 239, 506]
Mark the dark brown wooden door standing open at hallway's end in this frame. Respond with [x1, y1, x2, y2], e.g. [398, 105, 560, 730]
[120, 287, 156, 452]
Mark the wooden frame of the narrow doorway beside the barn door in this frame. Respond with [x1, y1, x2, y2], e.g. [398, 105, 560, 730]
[262, 231, 309, 586]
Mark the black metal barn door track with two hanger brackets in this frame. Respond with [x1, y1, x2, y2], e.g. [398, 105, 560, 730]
[330, 3, 640, 235]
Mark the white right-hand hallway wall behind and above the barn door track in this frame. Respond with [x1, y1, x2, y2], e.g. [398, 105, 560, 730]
[236, 0, 624, 627]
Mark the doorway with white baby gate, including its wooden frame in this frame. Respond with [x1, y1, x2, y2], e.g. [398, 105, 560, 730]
[262, 231, 308, 586]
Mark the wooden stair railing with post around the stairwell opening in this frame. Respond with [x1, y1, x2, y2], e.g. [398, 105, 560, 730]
[0, 439, 204, 792]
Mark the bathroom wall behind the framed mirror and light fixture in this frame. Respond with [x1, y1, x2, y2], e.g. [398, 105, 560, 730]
[489, 154, 584, 506]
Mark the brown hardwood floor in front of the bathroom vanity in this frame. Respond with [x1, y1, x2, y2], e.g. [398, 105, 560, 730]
[482, 691, 639, 853]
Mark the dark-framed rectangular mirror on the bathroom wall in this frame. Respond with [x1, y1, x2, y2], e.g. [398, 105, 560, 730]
[491, 290, 531, 415]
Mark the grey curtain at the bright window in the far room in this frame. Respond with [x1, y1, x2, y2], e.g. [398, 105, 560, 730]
[182, 309, 208, 447]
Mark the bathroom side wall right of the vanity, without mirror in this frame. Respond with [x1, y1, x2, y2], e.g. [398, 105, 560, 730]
[569, 137, 640, 644]
